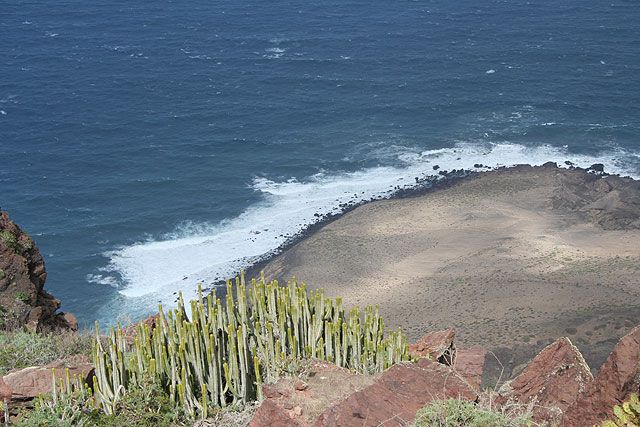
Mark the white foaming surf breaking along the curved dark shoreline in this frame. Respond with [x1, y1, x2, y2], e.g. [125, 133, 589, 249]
[104, 143, 638, 306]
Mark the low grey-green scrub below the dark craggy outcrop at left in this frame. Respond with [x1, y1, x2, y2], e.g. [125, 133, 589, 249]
[0, 331, 93, 375]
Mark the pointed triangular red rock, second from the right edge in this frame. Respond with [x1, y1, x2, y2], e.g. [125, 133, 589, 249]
[498, 338, 593, 427]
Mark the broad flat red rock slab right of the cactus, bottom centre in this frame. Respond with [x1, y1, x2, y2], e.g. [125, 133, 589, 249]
[314, 358, 478, 427]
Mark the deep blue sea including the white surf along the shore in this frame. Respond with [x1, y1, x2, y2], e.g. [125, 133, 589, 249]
[0, 0, 640, 326]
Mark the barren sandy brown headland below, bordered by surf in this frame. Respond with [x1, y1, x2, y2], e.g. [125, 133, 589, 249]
[264, 165, 640, 384]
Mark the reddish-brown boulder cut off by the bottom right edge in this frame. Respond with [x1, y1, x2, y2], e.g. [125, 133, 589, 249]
[564, 326, 640, 427]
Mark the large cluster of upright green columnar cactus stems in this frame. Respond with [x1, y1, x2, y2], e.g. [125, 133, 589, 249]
[92, 275, 410, 417]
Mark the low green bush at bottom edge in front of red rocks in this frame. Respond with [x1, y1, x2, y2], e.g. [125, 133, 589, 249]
[414, 399, 530, 427]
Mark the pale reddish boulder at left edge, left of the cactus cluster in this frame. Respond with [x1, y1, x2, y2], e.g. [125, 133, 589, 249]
[3, 361, 93, 401]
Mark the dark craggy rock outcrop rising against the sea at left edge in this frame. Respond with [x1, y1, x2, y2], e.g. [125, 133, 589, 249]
[0, 211, 77, 332]
